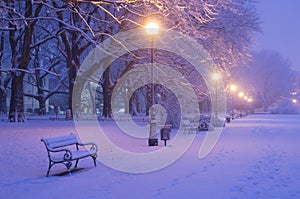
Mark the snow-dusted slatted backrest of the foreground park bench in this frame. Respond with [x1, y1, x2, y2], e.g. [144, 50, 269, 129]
[42, 134, 78, 149]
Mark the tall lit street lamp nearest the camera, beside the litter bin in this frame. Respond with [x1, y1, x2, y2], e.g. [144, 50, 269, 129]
[145, 22, 159, 146]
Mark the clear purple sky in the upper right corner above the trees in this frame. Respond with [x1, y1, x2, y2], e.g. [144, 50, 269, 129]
[255, 0, 300, 71]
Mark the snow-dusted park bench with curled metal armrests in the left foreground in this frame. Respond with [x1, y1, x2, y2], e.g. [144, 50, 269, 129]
[41, 134, 98, 177]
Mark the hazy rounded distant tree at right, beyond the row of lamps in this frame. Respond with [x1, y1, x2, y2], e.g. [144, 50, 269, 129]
[233, 50, 298, 111]
